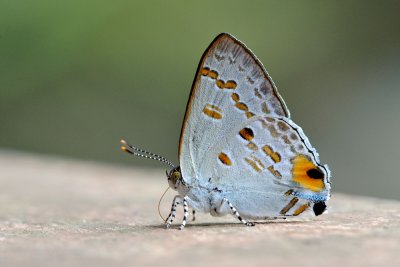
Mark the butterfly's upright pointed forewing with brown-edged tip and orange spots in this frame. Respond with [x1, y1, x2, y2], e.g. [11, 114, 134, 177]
[179, 33, 290, 183]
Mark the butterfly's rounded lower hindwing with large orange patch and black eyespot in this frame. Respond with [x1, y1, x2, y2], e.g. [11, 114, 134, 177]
[205, 116, 330, 218]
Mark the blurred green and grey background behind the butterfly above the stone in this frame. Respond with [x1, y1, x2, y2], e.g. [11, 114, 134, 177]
[0, 0, 400, 199]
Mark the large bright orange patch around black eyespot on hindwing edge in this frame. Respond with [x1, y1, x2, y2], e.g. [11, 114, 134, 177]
[292, 155, 325, 192]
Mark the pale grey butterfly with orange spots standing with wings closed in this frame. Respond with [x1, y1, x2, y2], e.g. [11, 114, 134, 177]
[122, 33, 331, 229]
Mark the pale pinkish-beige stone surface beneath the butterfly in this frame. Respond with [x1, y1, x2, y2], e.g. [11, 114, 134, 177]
[0, 151, 400, 267]
